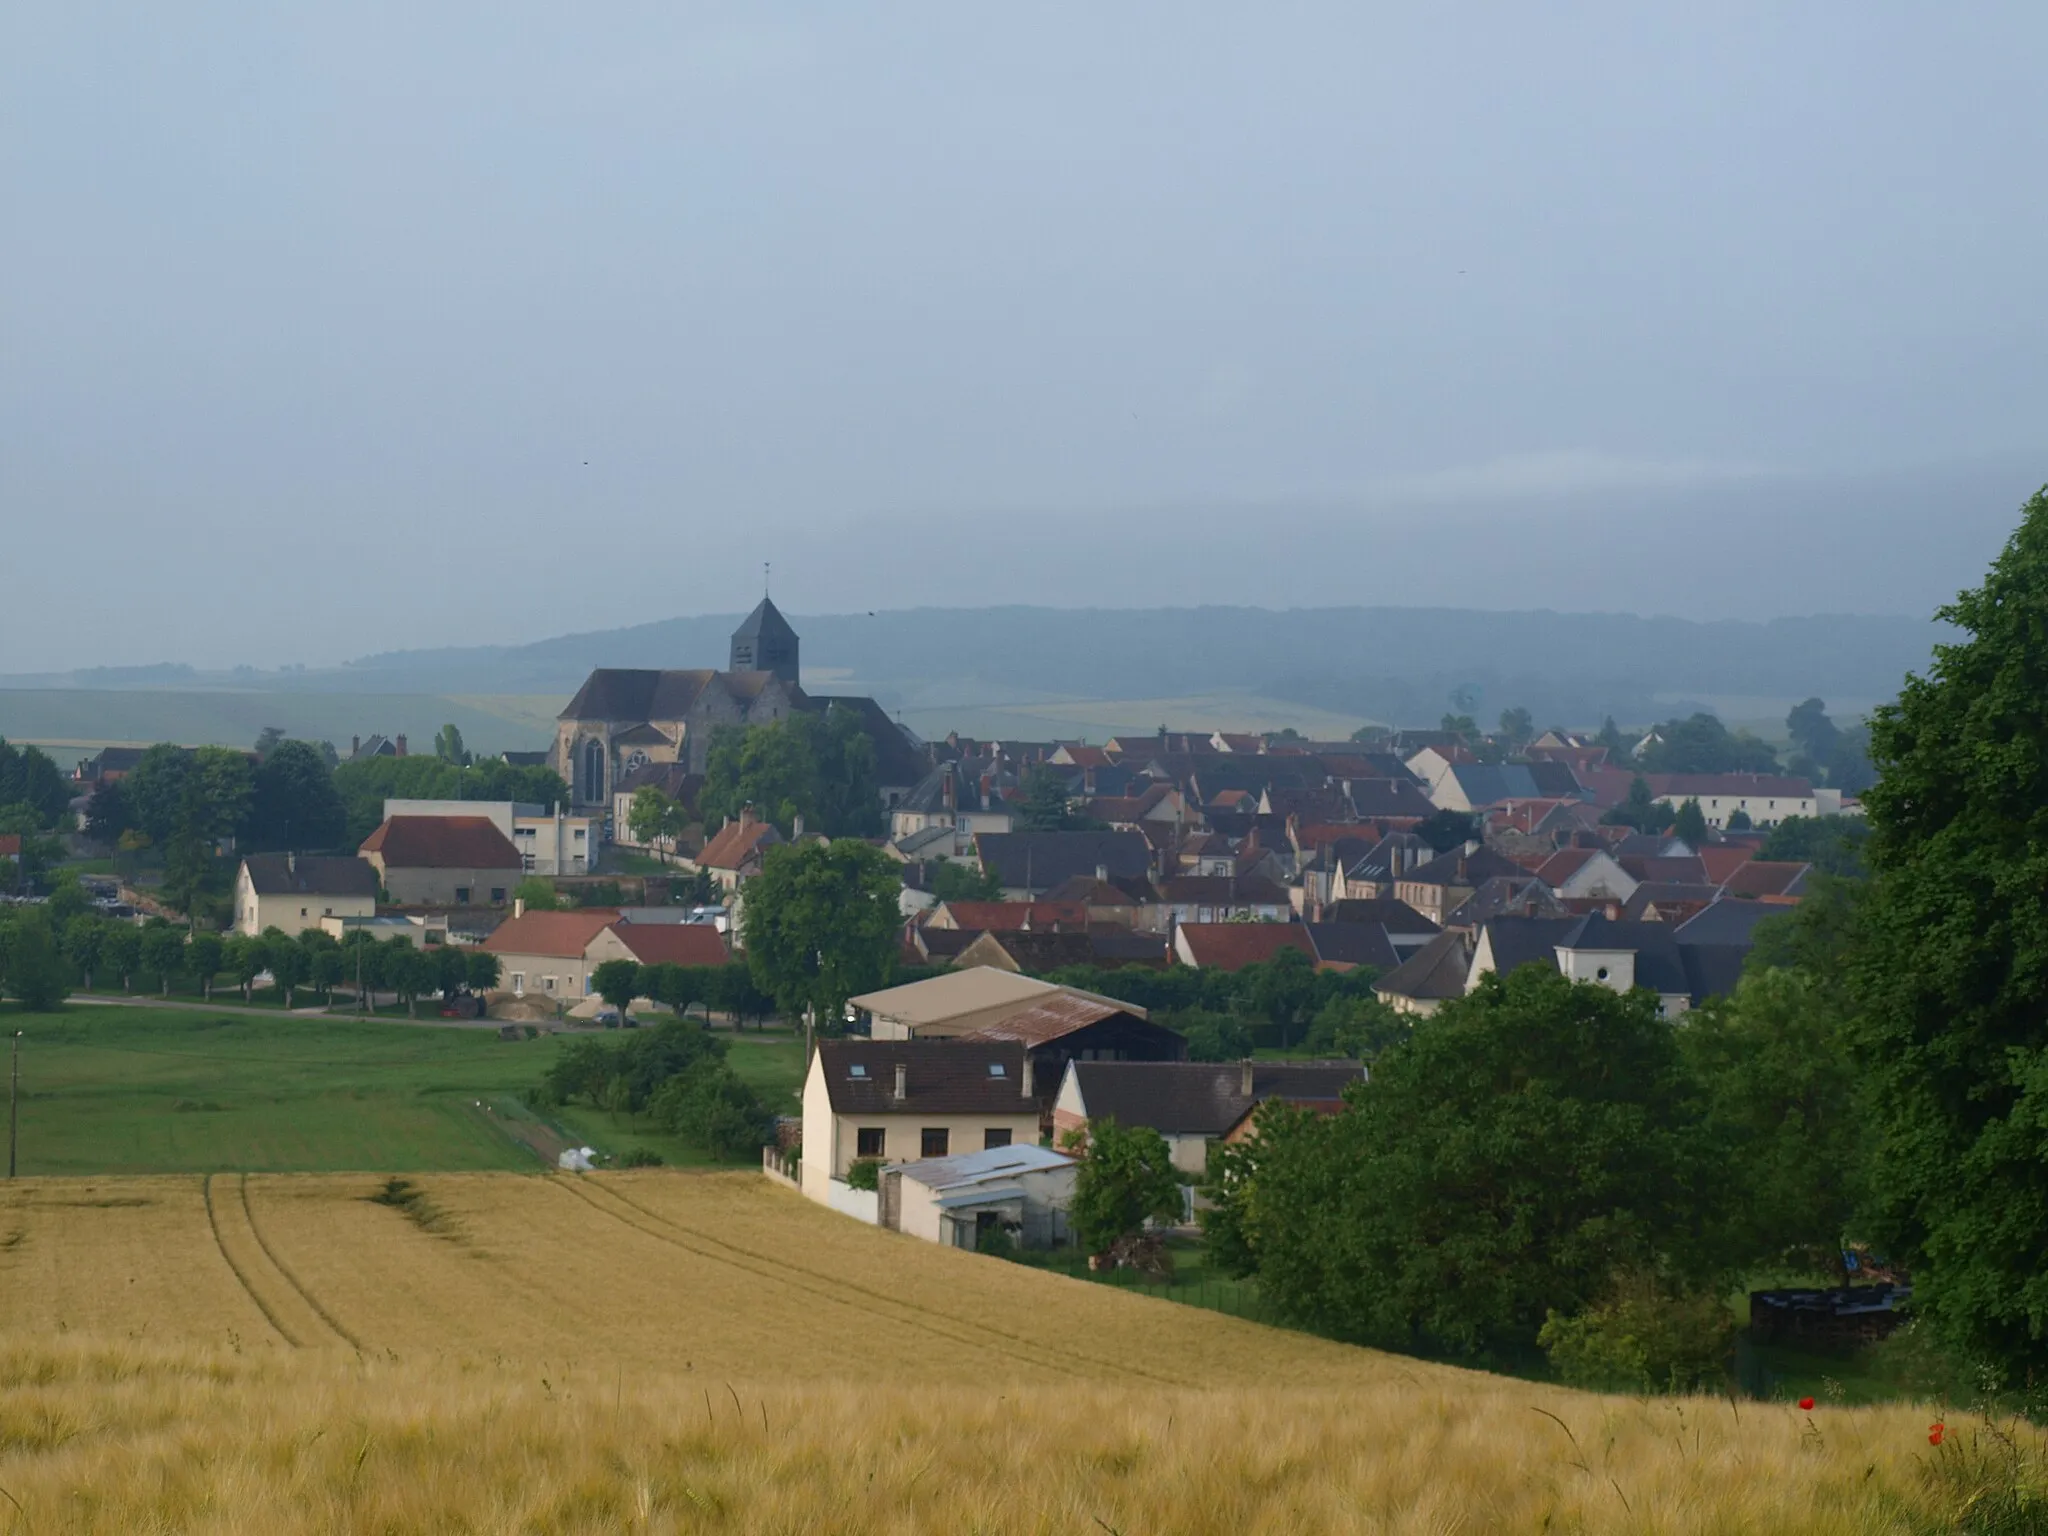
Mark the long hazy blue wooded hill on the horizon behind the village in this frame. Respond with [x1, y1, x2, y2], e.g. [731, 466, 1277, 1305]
[0, 606, 1939, 741]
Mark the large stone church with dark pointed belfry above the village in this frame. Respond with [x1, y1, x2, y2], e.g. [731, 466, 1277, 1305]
[549, 598, 930, 815]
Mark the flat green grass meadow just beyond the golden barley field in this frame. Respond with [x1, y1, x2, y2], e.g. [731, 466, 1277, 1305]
[0, 1006, 803, 1174]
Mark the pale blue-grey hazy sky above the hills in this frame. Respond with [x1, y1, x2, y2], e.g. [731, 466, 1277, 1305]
[0, 0, 2048, 672]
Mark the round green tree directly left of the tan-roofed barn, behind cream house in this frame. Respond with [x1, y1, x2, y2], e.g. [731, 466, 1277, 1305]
[741, 838, 903, 1034]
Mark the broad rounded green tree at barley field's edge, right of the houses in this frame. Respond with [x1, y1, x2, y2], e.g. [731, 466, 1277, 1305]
[1245, 967, 1726, 1356]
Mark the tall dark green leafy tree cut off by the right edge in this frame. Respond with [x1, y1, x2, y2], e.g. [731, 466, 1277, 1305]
[1853, 489, 2048, 1389]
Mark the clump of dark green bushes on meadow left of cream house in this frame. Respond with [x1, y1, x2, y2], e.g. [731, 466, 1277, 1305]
[537, 1020, 774, 1157]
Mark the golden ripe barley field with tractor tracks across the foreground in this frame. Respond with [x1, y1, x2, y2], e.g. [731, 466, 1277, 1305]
[0, 1171, 2038, 1536]
